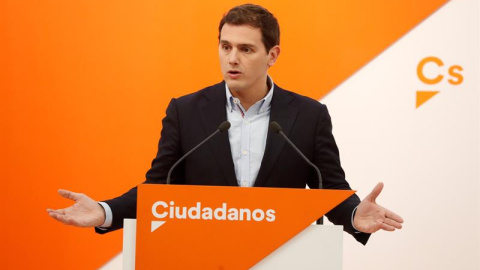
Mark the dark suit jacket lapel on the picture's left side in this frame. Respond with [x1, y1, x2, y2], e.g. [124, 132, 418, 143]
[199, 82, 238, 186]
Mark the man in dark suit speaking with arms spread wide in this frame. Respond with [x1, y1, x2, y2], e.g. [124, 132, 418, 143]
[48, 5, 403, 244]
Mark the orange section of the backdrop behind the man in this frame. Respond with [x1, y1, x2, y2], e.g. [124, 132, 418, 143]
[0, 0, 446, 269]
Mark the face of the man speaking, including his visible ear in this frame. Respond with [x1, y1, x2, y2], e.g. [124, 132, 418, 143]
[218, 24, 280, 95]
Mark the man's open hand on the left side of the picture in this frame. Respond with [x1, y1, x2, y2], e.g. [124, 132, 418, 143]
[47, 189, 105, 227]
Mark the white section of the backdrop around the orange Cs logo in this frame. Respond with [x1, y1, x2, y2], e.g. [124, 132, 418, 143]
[321, 0, 479, 270]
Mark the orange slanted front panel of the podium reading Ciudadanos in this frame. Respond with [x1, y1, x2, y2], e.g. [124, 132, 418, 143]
[135, 185, 355, 270]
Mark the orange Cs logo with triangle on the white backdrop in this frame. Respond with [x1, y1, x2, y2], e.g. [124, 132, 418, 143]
[416, 56, 463, 108]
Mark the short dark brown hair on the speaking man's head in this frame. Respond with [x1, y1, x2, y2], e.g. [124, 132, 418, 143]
[218, 4, 280, 53]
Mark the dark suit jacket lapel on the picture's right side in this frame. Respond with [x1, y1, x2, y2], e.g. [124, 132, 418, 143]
[254, 85, 298, 187]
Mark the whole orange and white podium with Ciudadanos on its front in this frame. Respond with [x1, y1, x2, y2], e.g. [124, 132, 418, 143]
[123, 185, 354, 270]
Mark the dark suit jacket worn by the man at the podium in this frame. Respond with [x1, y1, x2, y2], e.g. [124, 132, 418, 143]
[97, 82, 369, 244]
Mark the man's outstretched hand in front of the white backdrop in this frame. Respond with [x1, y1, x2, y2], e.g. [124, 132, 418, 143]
[353, 183, 403, 233]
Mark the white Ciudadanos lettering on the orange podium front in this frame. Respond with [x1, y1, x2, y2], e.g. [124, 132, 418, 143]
[152, 201, 276, 222]
